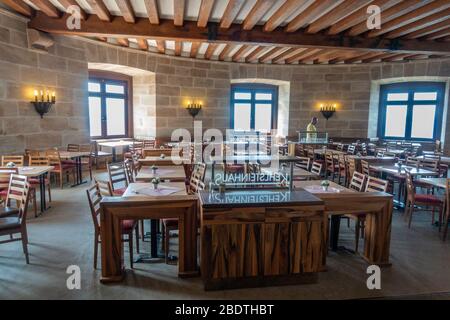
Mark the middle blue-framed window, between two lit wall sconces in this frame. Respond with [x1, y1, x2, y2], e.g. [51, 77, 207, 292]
[231, 84, 278, 132]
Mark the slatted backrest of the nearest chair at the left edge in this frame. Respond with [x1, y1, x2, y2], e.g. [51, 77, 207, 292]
[6, 174, 30, 223]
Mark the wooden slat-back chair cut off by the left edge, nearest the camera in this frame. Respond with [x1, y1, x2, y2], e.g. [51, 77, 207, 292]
[0, 174, 30, 264]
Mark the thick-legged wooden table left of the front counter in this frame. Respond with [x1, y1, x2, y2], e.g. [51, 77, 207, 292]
[100, 182, 198, 283]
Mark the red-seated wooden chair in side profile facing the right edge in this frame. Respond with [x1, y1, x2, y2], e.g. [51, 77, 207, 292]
[405, 171, 444, 232]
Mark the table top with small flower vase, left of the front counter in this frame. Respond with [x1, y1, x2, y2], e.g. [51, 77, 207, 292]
[118, 182, 189, 201]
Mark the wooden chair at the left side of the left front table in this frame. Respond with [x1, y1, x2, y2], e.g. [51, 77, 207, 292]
[86, 183, 139, 269]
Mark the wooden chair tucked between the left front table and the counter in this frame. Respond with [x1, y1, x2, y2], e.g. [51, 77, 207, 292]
[162, 163, 206, 264]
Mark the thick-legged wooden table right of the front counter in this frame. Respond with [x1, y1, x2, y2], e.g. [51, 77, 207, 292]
[294, 181, 393, 266]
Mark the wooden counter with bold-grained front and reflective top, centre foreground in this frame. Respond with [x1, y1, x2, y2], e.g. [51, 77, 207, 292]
[199, 189, 328, 290]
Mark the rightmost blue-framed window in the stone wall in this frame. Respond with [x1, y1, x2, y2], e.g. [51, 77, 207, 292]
[378, 82, 445, 141]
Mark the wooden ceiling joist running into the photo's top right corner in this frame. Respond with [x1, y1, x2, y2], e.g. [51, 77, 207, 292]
[367, 0, 450, 38]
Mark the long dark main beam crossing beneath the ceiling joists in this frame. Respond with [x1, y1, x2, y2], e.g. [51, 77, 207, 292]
[28, 12, 450, 54]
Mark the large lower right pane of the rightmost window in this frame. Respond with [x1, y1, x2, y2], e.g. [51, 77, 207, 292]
[411, 105, 436, 139]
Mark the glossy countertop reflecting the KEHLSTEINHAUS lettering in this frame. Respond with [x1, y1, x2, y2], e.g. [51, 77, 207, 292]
[199, 189, 323, 208]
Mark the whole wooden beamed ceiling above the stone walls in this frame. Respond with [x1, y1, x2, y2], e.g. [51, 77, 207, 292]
[0, 0, 450, 64]
